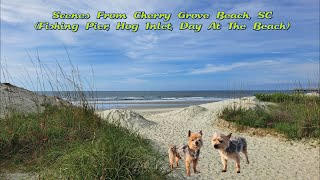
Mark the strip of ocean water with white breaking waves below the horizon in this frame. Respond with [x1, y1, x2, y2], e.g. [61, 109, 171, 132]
[42, 91, 292, 109]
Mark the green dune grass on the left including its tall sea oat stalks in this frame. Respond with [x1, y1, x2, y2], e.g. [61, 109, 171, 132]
[0, 50, 166, 180]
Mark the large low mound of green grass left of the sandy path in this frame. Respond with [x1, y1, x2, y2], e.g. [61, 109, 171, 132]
[0, 106, 165, 179]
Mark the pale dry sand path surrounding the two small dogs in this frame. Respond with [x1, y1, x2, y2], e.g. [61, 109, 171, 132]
[100, 97, 320, 180]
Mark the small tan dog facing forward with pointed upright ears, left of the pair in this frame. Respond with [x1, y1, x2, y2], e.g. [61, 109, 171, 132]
[168, 130, 203, 176]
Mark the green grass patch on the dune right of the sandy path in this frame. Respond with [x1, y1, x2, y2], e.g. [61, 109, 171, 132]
[220, 93, 320, 139]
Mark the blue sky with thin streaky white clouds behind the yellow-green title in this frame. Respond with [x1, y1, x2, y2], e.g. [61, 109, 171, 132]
[1, 0, 319, 91]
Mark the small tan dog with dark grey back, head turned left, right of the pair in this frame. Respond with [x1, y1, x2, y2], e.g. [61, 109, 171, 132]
[212, 133, 249, 173]
